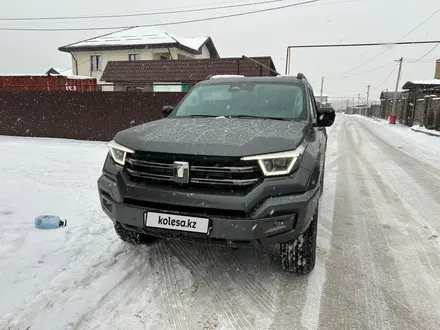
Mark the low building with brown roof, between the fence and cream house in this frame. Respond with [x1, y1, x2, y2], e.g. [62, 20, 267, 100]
[101, 56, 276, 92]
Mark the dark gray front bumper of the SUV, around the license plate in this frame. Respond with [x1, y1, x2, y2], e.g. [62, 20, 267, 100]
[98, 172, 320, 247]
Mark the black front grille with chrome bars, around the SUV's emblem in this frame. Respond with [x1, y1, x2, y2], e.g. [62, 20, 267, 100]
[126, 152, 260, 187]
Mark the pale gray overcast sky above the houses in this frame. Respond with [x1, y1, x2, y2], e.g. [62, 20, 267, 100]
[0, 0, 440, 100]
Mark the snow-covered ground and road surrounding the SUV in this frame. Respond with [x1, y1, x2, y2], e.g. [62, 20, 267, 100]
[0, 115, 440, 330]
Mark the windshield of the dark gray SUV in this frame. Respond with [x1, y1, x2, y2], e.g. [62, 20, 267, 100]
[175, 82, 307, 120]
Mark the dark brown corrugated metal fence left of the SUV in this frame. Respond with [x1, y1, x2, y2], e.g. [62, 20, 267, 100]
[0, 91, 185, 141]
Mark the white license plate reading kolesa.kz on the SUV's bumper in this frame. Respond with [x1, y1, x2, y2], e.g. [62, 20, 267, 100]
[144, 212, 209, 234]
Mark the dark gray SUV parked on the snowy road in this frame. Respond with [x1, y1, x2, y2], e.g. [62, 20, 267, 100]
[98, 74, 335, 274]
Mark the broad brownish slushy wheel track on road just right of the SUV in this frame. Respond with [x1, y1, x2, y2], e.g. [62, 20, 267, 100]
[320, 119, 394, 329]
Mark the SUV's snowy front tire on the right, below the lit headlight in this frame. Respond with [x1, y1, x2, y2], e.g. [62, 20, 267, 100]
[280, 207, 318, 274]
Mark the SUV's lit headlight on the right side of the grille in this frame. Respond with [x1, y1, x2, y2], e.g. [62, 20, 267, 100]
[241, 146, 305, 176]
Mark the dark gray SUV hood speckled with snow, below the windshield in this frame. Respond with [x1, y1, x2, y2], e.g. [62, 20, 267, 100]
[114, 118, 310, 157]
